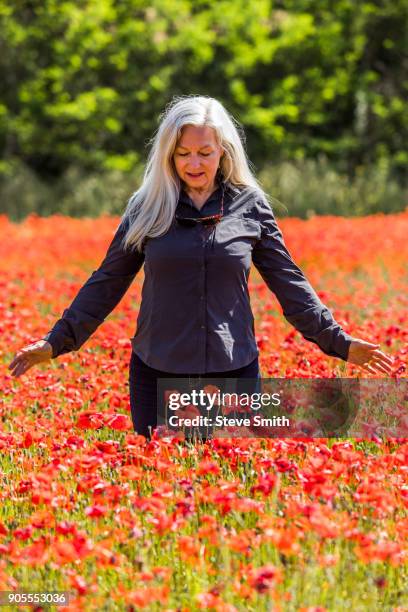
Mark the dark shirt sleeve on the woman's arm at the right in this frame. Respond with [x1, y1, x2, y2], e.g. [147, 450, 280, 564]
[252, 198, 352, 361]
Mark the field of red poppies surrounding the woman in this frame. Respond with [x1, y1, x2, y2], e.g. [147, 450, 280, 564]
[0, 212, 408, 612]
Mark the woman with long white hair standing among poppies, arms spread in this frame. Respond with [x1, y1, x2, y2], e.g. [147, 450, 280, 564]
[9, 96, 392, 437]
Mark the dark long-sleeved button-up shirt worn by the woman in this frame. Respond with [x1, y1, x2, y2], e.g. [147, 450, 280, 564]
[44, 183, 351, 374]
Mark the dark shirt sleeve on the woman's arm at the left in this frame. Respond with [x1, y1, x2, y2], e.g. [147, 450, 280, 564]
[43, 220, 144, 359]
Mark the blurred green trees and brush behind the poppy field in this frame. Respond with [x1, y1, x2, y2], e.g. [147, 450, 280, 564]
[0, 0, 408, 218]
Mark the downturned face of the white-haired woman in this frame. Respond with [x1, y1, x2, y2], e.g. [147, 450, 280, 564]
[173, 125, 223, 191]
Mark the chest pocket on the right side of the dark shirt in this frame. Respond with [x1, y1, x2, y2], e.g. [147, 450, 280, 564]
[214, 215, 261, 257]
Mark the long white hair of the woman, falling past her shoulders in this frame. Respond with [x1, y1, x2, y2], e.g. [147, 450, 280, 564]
[121, 95, 267, 251]
